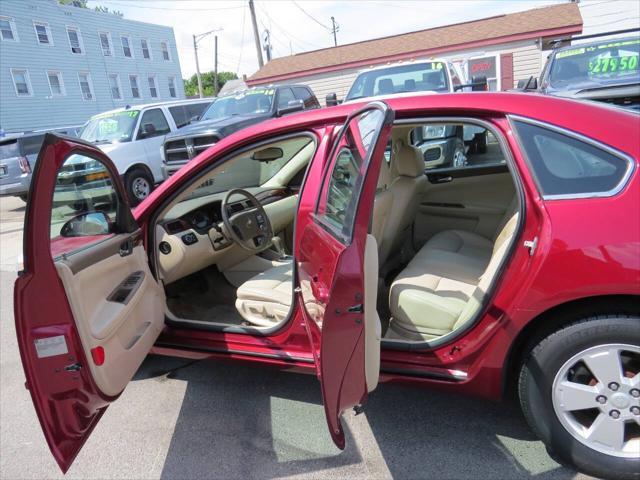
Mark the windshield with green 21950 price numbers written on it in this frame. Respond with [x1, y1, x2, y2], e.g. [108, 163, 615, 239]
[549, 39, 640, 90]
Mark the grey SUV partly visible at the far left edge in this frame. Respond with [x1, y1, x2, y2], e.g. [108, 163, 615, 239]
[0, 127, 79, 202]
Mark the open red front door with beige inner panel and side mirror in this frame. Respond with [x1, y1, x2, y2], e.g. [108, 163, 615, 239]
[14, 134, 165, 472]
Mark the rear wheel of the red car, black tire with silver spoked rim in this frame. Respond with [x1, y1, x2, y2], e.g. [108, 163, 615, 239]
[518, 315, 640, 479]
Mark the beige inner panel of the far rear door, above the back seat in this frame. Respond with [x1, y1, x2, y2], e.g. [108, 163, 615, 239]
[414, 169, 515, 247]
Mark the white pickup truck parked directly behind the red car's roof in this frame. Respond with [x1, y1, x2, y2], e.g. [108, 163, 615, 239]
[326, 59, 488, 168]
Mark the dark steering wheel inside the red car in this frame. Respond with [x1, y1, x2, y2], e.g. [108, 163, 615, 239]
[221, 188, 273, 253]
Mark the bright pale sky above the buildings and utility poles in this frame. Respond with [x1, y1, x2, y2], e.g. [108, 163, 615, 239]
[88, 0, 564, 78]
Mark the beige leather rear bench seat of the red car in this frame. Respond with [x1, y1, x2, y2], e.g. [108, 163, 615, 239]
[385, 198, 518, 341]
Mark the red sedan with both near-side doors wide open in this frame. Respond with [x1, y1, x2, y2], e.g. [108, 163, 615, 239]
[15, 93, 640, 478]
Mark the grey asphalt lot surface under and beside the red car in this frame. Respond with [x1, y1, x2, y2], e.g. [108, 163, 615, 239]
[0, 198, 588, 479]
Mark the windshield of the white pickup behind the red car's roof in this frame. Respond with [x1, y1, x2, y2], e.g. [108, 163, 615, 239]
[345, 62, 449, 101]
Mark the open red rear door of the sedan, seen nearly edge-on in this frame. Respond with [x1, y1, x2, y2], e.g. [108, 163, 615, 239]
[296, 102, 393, 449]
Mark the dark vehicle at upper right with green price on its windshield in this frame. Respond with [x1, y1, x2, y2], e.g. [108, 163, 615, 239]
[519, 33, 640, 111]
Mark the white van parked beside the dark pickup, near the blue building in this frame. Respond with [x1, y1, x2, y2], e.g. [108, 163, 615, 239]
[79, 98, 212, 205]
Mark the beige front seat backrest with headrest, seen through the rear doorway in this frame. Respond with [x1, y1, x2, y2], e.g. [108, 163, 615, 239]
[378, 139, 427, 271]
